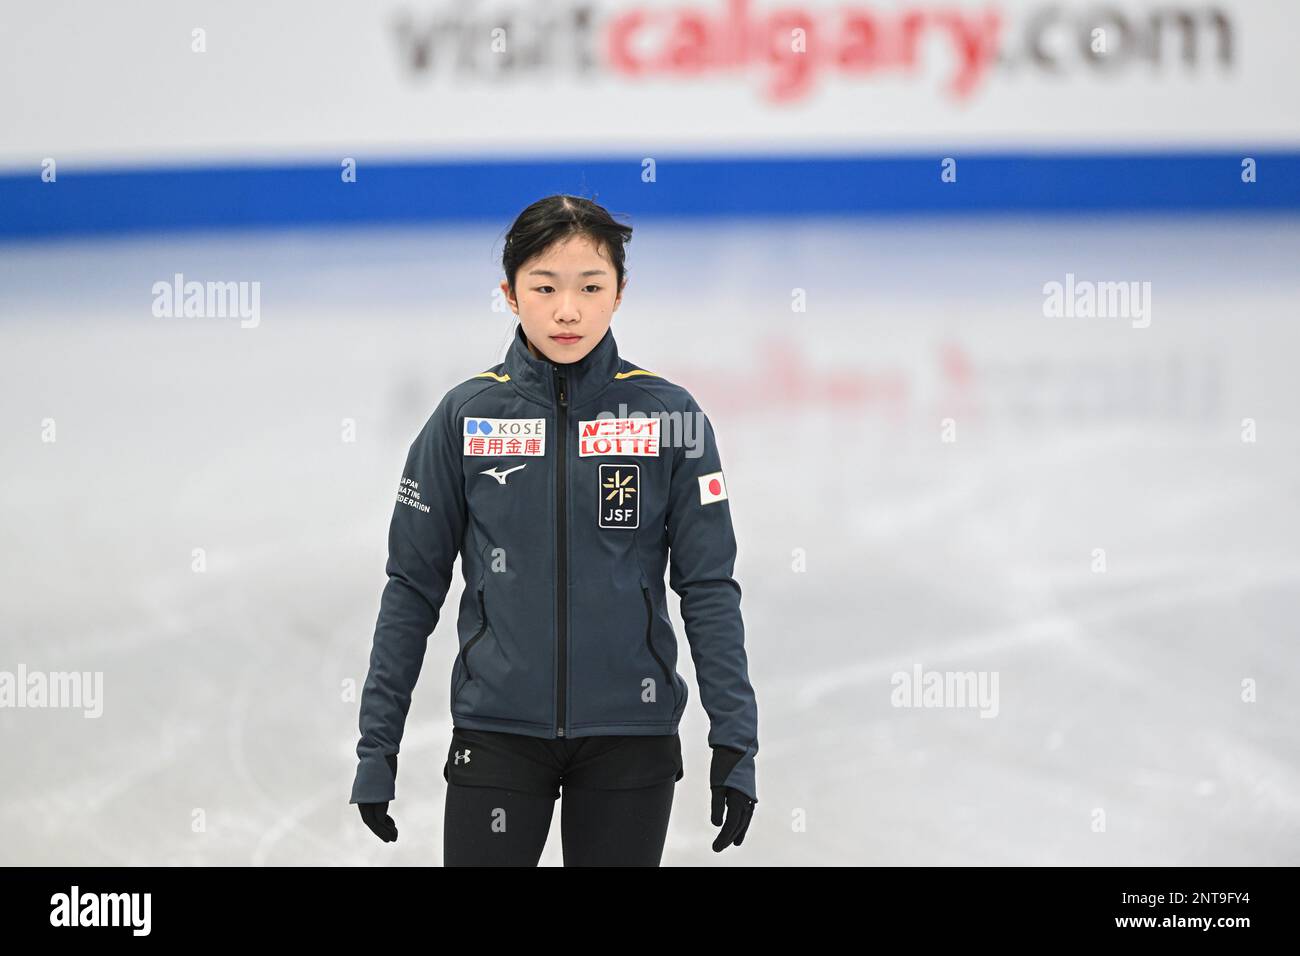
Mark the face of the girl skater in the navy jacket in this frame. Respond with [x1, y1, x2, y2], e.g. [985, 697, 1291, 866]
[501, 235, 628, 364]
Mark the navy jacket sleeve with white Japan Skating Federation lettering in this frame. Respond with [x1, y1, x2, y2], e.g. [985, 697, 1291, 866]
[351, 393, 465, 804]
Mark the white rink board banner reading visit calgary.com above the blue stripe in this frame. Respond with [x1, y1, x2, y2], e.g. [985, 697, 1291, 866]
[0, 0, 1300, 166]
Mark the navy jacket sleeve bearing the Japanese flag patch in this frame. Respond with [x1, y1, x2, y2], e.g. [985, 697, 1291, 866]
[667, 395, 758, 801]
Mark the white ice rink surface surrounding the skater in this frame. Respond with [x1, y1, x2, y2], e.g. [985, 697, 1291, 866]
[0, 217, 1300, 865]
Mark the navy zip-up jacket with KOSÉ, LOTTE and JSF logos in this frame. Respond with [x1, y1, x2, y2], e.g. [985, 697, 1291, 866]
[351, 325, 758, 803]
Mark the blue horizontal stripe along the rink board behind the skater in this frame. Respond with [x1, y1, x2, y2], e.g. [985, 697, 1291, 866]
[0, 150, 1300, 238]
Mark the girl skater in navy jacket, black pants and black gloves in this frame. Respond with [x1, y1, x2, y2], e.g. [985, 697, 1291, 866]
[351, 195, 758, 866]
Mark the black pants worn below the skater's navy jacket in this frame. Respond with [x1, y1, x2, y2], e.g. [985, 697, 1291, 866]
[443, 727, 684, 866]
